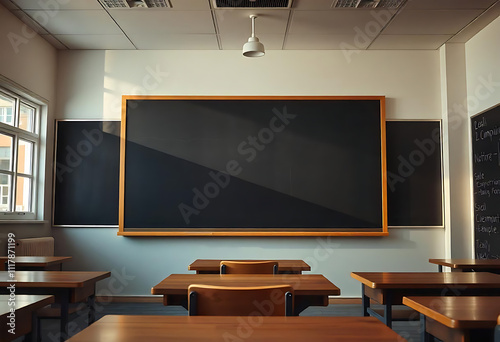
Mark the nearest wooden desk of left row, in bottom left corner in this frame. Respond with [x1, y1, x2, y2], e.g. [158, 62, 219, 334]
[0, 294, 54, 342]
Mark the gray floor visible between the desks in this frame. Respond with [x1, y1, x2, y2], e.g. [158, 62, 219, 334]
[25, 303, 428, 342]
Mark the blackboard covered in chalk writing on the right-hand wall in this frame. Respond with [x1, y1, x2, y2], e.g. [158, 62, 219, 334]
[471, 105, 500, 259]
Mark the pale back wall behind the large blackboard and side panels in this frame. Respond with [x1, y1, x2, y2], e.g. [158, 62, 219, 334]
[53, 51, 445, 297]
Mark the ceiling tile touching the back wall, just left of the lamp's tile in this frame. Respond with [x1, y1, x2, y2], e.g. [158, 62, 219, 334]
[129, 33, 219, 50]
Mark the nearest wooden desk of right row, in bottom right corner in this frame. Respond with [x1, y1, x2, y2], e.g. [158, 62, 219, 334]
[403, 296, 500, 341]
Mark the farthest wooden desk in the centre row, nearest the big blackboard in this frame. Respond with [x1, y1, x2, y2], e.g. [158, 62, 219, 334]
[188, 259, 311, 274]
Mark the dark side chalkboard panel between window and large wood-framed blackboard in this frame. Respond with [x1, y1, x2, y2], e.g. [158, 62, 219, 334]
[52, 121, 120, 227]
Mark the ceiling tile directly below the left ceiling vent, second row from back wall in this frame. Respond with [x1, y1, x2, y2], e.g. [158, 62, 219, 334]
[110, 9, 215, 35]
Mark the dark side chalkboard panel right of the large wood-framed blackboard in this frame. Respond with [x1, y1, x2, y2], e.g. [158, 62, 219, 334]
[386, 121, 443, 227]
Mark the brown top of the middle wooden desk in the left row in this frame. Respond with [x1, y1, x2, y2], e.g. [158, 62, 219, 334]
[0, 271, 111, 288]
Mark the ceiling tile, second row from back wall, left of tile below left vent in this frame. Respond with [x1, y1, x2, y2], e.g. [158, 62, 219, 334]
[26, 10, 121, 34]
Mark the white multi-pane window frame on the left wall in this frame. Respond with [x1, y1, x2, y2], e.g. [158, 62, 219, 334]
[0, 84, 40, 222]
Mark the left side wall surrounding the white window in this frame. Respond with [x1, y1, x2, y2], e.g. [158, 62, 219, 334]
[0, 5, 57, 243]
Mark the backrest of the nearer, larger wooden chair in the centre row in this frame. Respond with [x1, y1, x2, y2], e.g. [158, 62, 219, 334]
[188, 284, 293, 316]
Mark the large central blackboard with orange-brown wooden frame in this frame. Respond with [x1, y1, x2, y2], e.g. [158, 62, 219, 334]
[119, 97, 387, 235]
